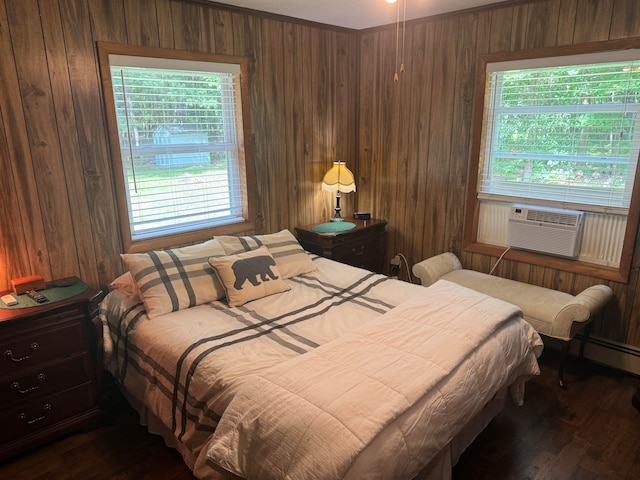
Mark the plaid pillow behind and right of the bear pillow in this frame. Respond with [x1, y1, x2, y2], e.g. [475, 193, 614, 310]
[215, 230, 316, 278]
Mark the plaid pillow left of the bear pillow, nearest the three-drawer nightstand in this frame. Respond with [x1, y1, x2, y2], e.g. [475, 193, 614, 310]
[121, 240, 225, 318]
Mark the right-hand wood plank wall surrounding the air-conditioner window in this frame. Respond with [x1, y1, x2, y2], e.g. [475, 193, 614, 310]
[357, 0, 640, 347]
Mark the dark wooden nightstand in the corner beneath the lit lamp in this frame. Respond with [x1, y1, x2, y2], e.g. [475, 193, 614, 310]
[295, 219, 387, 273]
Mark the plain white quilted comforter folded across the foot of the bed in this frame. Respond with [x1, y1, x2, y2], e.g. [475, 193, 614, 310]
[206, 281, 542, 480]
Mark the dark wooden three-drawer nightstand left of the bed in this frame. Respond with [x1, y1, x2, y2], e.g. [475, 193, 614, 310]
[0, 279, 102, 461]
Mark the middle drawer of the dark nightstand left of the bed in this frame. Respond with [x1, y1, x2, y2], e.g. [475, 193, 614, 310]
[0, 355, 91, 410]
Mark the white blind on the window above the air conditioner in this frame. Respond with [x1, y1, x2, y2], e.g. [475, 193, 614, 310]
[478, 50, 640, 213]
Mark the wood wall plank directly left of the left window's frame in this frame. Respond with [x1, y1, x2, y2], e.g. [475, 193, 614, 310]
[60, 0, 123, 287]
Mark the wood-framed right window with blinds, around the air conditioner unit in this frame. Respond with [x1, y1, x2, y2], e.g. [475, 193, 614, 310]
[465, 42, 640, 280]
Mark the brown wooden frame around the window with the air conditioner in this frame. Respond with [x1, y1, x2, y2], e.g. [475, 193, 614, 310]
[463, 37, 640, 283]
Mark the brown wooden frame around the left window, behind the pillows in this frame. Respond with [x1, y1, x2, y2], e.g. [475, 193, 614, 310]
[97, 42, 256, 253]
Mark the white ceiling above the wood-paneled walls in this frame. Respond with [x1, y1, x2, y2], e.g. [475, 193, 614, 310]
[212, 0, 505, 30]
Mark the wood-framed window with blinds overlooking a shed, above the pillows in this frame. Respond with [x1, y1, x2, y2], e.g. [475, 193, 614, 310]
[99, 44, 251, 251]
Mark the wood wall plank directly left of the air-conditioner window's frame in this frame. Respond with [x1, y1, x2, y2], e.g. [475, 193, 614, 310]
[443, 14, 478, 252]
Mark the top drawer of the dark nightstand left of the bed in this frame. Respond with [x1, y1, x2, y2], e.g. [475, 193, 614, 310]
[0, 321, 85, 376]
